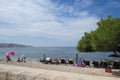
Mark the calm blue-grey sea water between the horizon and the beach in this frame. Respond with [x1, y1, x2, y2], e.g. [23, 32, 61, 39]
[0, 47, 120, 60]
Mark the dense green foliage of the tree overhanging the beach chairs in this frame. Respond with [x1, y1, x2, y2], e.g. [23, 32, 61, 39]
[77, 15, 120, 52]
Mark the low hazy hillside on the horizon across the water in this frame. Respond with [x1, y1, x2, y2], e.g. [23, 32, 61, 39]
[0, 43, 32, 48]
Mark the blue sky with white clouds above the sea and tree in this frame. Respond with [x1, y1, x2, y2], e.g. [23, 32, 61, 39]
[0, 0, 120, 47]
